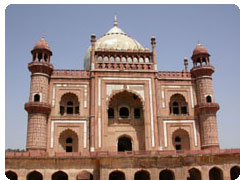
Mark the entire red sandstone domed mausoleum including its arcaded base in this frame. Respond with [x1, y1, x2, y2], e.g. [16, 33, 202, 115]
[6, 17, 240, 180]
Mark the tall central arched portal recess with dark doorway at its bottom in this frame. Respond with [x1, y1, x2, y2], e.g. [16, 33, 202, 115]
[106, 90, 145, 152]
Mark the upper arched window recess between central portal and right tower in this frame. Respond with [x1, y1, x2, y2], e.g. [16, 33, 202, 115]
[170, 94, 188, 115]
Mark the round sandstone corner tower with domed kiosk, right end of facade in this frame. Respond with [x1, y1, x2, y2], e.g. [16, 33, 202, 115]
[191, 44, 219, 149]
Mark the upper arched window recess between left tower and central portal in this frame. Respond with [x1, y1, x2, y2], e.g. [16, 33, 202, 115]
[59, 93, 79, 115]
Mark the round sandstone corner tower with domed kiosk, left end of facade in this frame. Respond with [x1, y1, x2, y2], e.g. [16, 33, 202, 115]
[25, 38, 53, 151]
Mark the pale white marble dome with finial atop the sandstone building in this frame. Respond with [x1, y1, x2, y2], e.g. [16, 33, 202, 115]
[84, 19, 144, 70]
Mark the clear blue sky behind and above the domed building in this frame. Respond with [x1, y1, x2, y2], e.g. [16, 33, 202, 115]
[5, 5, 240, 148]
